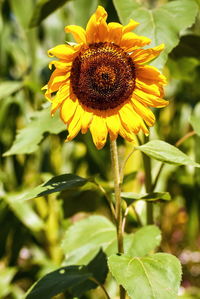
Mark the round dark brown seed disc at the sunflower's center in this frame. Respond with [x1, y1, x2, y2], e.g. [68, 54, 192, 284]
[70, 43, 135, 110]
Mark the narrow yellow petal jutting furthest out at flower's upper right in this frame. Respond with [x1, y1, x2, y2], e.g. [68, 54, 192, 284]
[131, 44, 165, 63]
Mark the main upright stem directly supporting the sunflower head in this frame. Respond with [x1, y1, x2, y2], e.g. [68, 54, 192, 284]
[110, 140, 126, 299]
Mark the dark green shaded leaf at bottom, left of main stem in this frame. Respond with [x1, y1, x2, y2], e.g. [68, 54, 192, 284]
[26, 251, 108, 299]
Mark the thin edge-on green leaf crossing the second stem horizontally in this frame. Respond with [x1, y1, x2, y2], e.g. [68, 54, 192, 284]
[121, 192, 171, 205]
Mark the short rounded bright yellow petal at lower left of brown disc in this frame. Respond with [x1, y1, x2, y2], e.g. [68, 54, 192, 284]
[60, 97, 78, 123]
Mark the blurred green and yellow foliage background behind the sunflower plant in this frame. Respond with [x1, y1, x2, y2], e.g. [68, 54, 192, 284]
[0, 0, 200, 299]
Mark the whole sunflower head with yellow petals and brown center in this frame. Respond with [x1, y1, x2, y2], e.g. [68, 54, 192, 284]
[44, 6, 168, 149]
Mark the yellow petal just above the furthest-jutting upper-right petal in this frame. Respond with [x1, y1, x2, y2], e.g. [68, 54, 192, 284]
[120, 32, 151, 51]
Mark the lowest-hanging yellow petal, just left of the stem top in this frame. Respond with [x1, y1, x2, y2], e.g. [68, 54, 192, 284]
[90, 115, 108, 149]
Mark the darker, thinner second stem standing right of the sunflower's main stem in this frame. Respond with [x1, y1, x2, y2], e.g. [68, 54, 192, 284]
[142, 136, 153, 224]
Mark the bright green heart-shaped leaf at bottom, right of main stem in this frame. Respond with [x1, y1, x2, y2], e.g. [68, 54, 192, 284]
[108, 253, 181, 299]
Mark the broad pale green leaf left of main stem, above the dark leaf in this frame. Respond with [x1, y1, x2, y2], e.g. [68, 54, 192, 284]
[62, 216, 116, 265]
